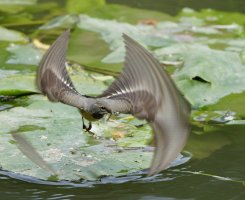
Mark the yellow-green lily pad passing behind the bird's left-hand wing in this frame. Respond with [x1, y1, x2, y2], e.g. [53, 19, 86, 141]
[0, 66, 110, 96]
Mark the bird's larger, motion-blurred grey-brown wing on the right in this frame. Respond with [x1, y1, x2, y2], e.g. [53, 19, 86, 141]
[101, 34, 190, 175]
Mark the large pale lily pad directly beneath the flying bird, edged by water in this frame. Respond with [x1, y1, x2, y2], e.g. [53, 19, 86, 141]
[0, 95, 188, 181]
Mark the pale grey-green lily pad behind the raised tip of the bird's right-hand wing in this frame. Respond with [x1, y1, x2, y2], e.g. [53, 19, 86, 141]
[78, 15, 174, 63]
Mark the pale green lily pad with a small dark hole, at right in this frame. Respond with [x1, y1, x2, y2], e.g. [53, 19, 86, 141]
[155, 44, 245, 107]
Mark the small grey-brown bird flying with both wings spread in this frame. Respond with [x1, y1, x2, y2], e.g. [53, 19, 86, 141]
[13, 30, 190, 175]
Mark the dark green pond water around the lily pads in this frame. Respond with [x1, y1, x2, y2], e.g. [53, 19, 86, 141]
[0, 0, 245, 200]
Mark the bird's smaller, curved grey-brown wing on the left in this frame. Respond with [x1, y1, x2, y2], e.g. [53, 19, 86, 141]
[37, 30, 86, 108]
